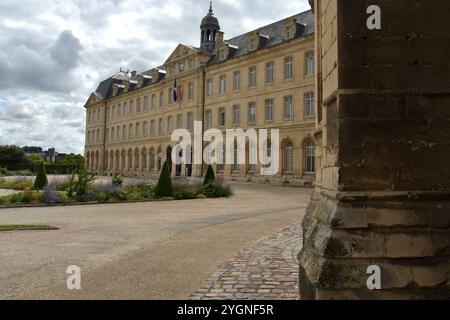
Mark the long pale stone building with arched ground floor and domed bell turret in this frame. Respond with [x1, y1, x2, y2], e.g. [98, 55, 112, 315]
[85, 3, 315, 185]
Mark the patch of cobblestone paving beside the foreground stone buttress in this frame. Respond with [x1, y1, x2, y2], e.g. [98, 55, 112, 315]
[191, 222, 302, 300]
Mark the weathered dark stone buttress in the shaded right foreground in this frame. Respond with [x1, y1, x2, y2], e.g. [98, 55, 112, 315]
[299, 0, 450, 299]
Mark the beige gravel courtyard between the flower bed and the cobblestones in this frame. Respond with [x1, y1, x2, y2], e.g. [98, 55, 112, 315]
[0, 184, 311, 299]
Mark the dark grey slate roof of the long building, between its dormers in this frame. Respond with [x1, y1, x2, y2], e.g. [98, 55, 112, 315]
[88, 10, 314, 105]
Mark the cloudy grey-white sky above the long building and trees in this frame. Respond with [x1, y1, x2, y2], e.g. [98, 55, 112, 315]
[0, 0, 309, 153]
